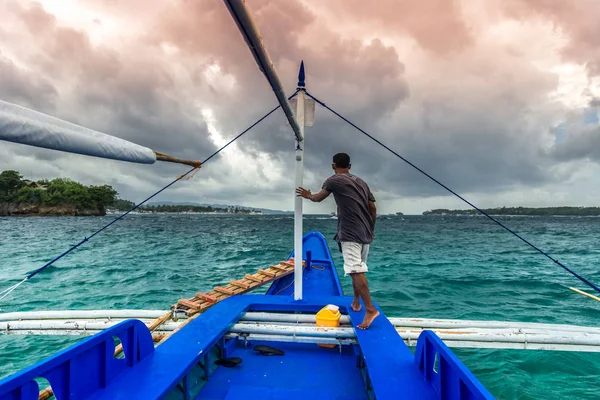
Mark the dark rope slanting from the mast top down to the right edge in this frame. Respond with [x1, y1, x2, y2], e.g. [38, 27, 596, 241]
[305, 92, 600, 293]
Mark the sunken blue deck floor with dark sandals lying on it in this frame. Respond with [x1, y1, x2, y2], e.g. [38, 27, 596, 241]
[197, 341, 367, 400]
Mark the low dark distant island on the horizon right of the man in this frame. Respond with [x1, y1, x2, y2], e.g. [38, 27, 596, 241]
[423, 207, 600, 216]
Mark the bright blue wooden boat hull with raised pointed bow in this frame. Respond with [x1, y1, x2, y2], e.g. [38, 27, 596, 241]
[0, 232, 493, 400]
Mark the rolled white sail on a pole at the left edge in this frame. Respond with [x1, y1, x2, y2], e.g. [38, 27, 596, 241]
[0, 100, 156, 164]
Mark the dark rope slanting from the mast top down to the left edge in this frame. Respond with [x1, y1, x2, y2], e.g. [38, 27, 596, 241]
[0, 90, 299, 300]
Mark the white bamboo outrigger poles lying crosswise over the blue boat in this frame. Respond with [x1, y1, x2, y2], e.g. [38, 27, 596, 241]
[0, 300, 600, 352]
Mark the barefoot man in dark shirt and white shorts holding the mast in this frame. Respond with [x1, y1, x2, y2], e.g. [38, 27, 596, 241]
[296, 153, 379, 329]
